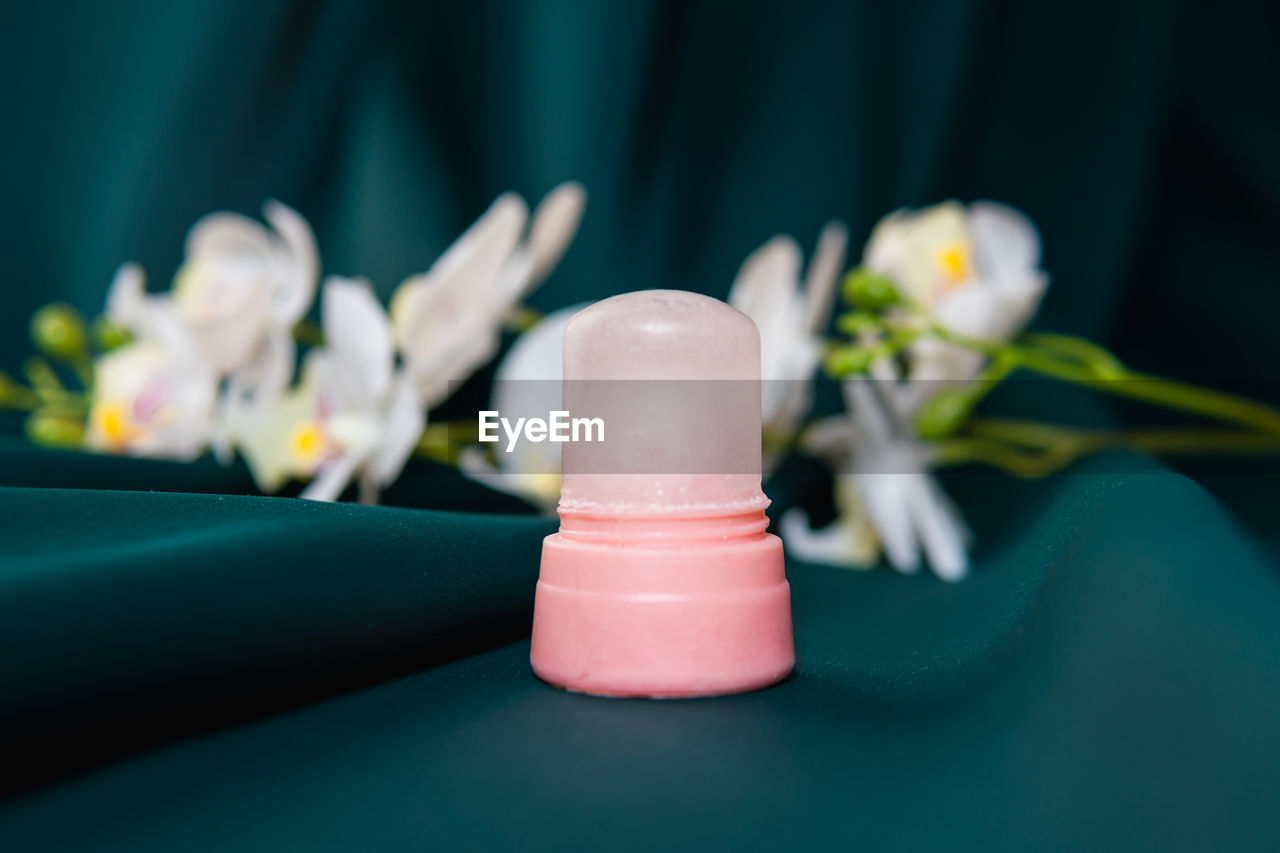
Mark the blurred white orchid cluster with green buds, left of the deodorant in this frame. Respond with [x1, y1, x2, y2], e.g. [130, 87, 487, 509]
[0, 183, 586, 502]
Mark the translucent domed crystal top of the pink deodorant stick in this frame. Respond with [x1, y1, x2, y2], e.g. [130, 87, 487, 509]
[561, 291, 768, 516]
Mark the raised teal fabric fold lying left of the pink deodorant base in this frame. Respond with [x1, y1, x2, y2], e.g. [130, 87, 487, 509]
[0, 488, 554, 789]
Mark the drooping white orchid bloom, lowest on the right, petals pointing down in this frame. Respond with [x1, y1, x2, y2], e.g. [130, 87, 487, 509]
[781, 379, 969, 580]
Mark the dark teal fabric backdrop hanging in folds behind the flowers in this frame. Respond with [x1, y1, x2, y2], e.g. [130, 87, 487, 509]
[0, 0, 1280, 366]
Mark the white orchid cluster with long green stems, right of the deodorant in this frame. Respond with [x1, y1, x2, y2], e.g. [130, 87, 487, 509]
[747, 202, 1280, 580]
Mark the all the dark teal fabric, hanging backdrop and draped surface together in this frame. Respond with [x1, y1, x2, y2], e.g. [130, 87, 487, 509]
[0, 0, 1280, 850]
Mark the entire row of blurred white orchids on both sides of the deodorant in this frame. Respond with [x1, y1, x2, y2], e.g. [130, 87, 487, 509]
[10, 183, 1280, 580]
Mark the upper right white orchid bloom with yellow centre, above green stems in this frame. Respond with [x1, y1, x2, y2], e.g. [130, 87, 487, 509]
[863, 201, 1048, 379]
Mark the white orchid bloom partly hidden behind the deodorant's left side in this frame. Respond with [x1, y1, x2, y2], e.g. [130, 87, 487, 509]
[458, 302, 590, 512]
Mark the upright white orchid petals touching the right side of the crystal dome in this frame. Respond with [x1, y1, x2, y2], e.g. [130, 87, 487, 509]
[728, 222, 849, 435]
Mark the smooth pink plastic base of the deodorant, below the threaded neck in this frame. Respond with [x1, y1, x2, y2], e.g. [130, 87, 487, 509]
[530, 522, 795, 698]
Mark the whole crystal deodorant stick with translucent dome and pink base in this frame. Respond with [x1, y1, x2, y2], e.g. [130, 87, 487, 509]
[531, 291, 795, 697]
